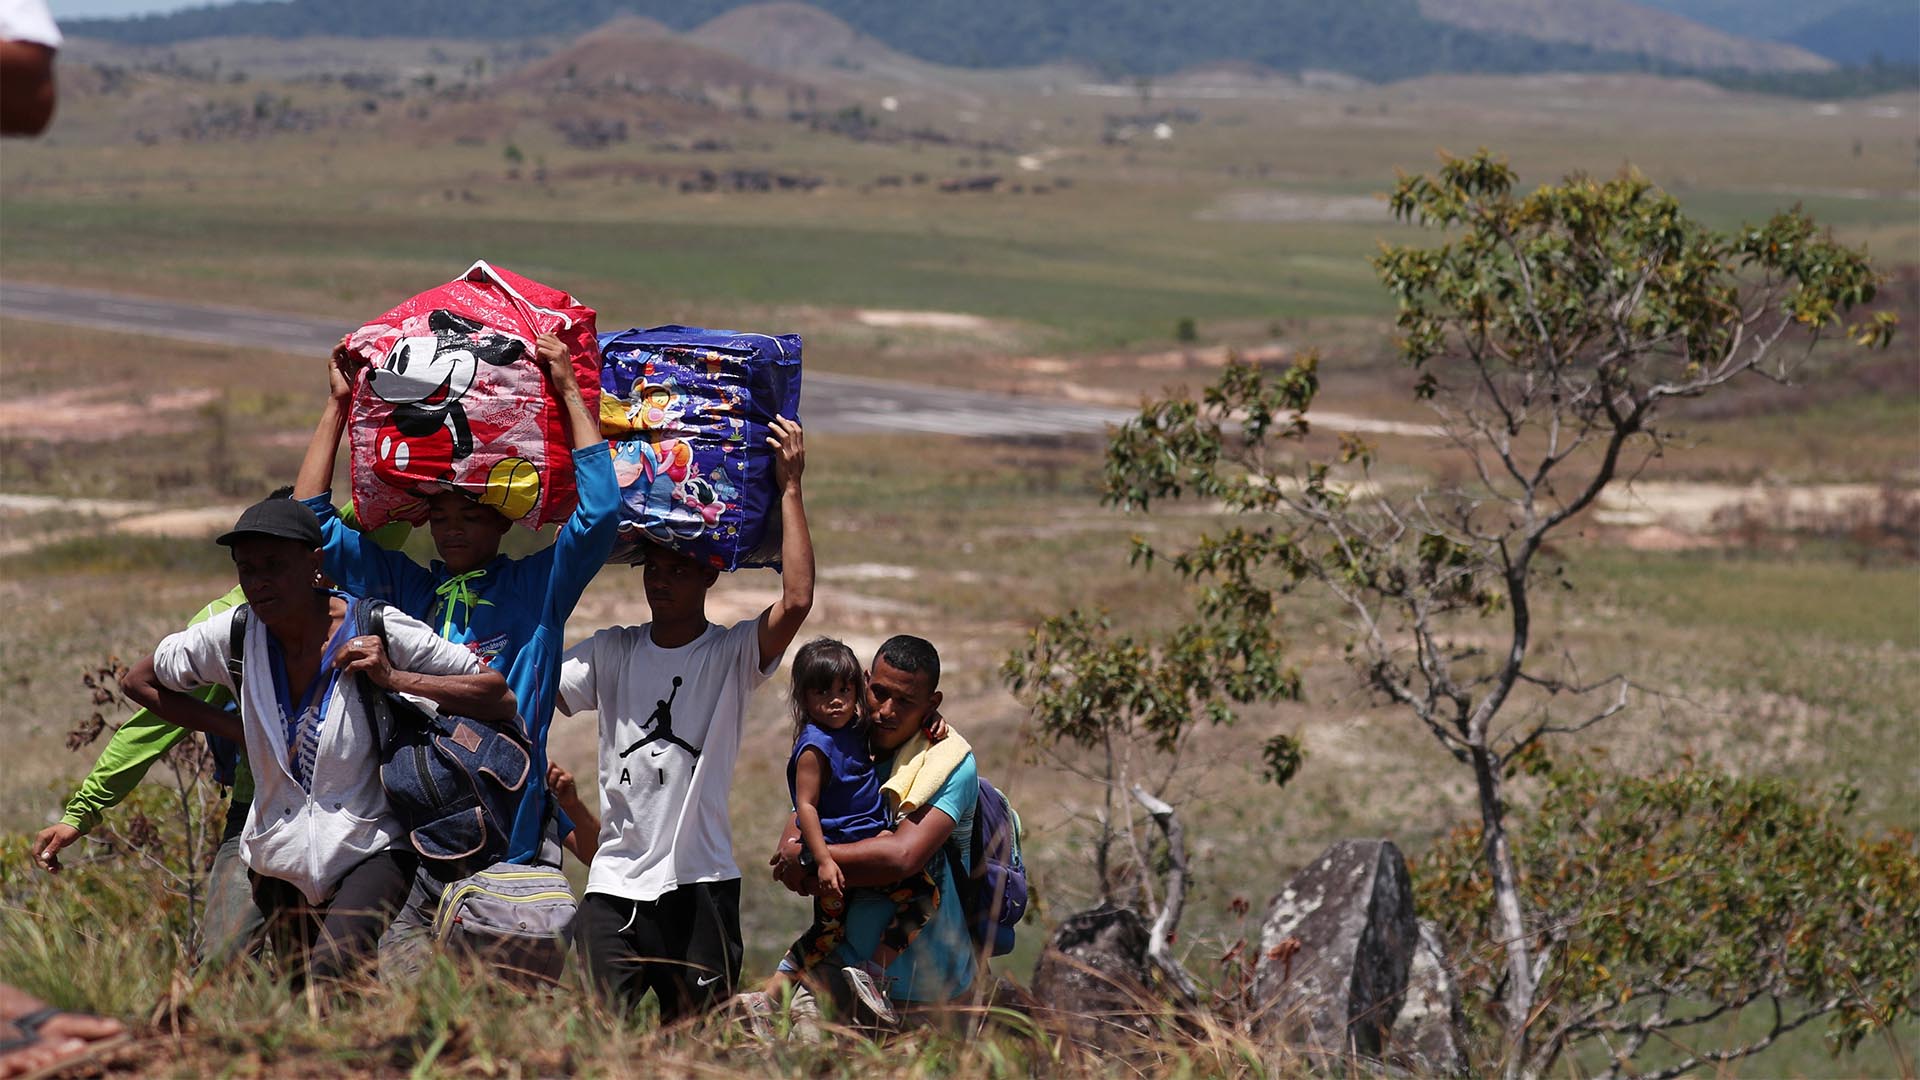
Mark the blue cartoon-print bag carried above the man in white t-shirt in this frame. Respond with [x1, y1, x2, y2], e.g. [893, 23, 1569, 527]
[599, 327, 801, 571]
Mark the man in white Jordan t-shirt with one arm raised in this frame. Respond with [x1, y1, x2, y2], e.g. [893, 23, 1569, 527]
[559, 419, 814, 1022]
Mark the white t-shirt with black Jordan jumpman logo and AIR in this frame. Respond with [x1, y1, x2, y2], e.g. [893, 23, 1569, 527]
[559, 617, 780, 899]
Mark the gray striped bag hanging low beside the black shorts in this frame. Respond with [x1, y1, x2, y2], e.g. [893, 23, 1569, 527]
[434, 863, 574, 988]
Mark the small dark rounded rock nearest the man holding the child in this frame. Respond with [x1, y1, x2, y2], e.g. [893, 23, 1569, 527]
[1033, 905, 1154, 1045]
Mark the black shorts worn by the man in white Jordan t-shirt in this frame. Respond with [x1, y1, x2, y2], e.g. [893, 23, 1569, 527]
[574, 878, 741, 1022]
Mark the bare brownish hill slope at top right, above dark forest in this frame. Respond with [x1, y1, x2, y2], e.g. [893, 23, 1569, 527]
[1421, 0, 1820, 71]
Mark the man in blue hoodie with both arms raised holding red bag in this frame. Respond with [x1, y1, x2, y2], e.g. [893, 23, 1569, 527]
[294, 326, 620, 967]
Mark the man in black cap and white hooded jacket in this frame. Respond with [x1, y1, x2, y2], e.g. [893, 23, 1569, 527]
[121, 500, 515, 980]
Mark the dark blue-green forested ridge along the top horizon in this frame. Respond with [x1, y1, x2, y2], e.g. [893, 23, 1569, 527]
[67, 0, 1827, 81]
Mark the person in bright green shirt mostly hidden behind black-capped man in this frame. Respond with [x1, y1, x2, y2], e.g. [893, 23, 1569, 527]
[33, 488, 411, 967]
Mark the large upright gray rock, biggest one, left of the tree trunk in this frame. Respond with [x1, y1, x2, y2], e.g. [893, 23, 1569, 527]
[1254, 840, 1419, 1061]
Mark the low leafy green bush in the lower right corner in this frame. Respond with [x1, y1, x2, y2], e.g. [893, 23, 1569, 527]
[1415, 763, 1920, 1080]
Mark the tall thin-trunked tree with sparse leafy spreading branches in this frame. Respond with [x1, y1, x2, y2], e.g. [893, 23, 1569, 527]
[1106, 150, 1893, 1076]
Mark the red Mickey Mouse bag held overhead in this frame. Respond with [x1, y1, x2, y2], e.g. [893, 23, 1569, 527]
[348, 261, 599, 528]
